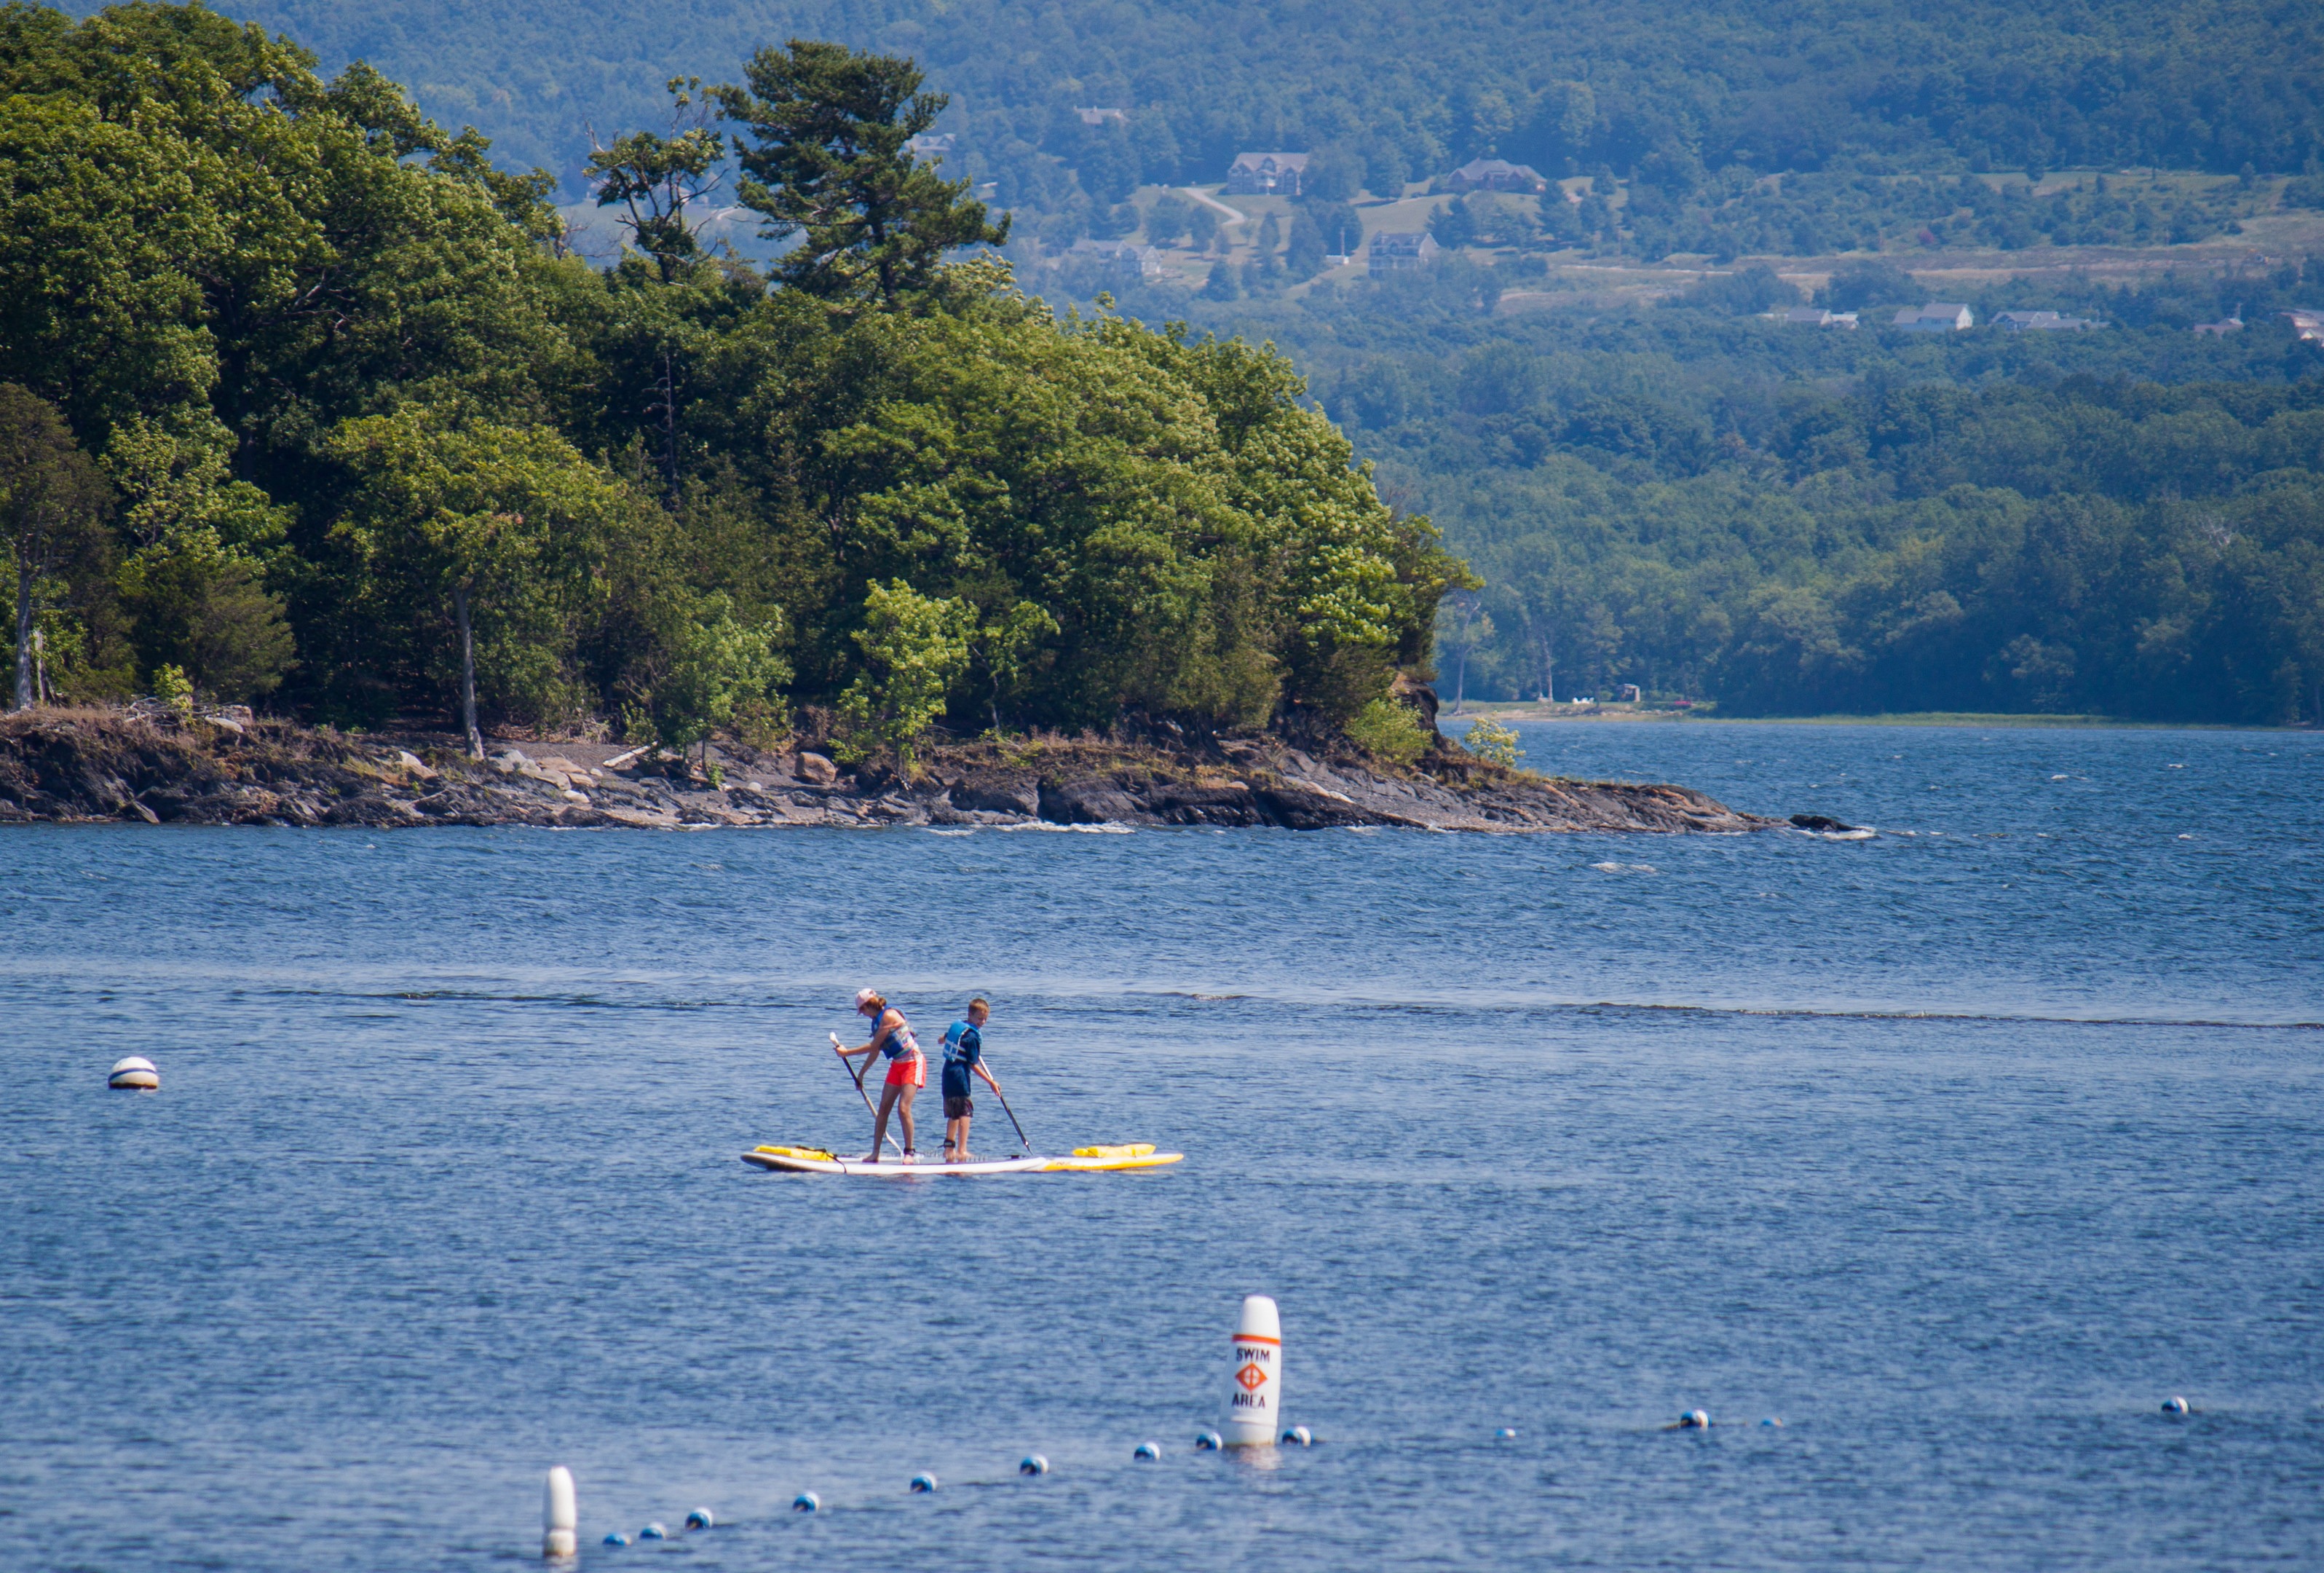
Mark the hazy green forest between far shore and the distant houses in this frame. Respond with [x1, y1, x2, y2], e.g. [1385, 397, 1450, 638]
[1155, 265, 2324, 722]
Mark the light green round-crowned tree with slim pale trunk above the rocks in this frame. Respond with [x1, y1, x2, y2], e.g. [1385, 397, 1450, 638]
[325, 406, 620, 760]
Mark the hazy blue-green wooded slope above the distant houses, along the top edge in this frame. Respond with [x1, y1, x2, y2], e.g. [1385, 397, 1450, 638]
[100, 0, 2324, 211]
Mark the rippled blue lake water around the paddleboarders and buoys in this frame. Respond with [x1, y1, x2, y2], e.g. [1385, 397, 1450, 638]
[0, 722, 2324, 1573]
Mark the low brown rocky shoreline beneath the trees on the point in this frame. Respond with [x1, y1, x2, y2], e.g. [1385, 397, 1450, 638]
[0, 706, 1782, 834]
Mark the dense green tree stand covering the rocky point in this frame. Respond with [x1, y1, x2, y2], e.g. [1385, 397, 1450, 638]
[0, 0, 1466, 757]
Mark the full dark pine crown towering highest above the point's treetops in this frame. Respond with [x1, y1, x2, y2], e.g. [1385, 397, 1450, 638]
[711, 39, 1008, 312]
